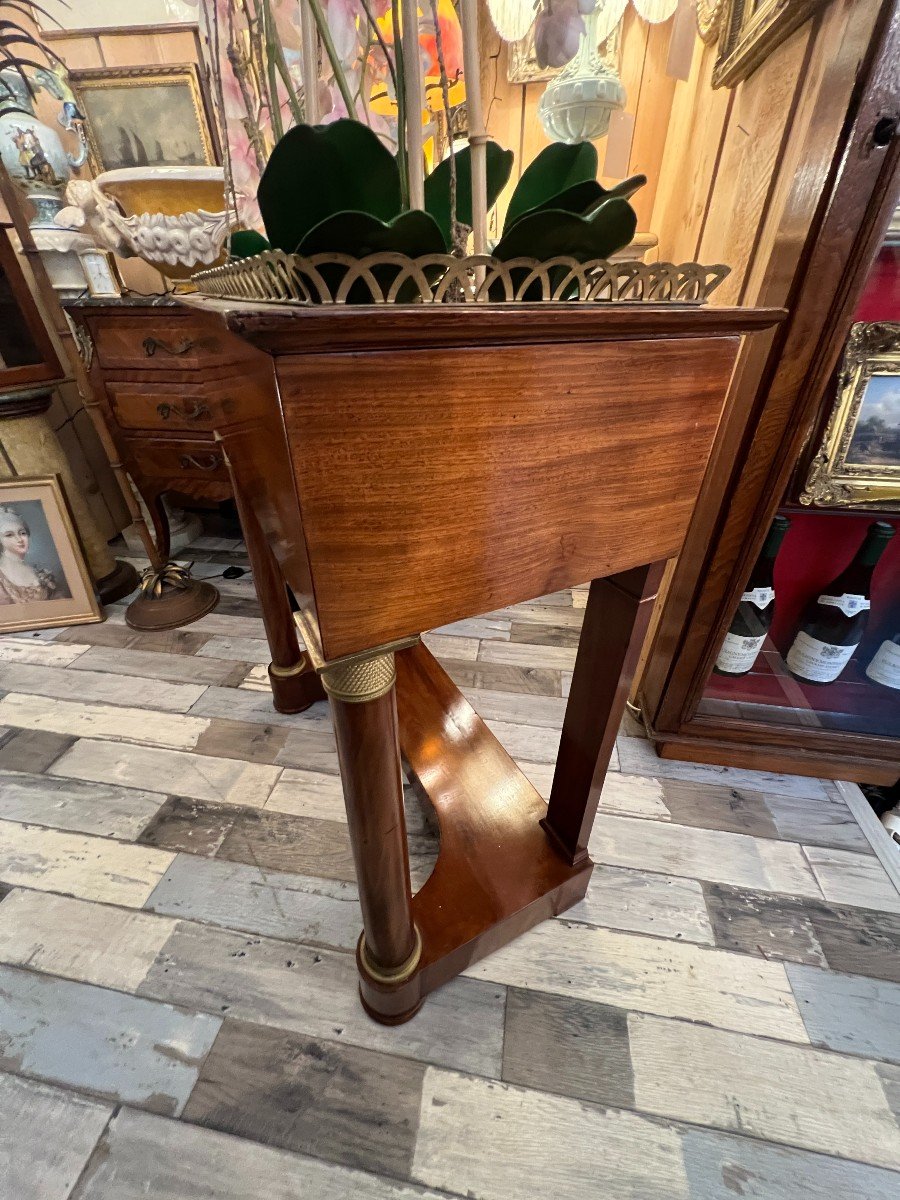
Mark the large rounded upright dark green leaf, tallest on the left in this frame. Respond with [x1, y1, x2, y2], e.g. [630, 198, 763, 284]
[257, 120, 401, 253]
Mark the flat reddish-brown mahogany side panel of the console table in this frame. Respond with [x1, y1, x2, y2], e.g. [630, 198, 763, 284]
[275, 336, 739, 659]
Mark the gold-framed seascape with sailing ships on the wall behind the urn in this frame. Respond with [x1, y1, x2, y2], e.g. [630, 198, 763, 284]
[68, 62, 220, 174]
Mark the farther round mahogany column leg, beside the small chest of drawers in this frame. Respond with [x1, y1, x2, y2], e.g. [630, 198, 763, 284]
[234, 477, 325, 713]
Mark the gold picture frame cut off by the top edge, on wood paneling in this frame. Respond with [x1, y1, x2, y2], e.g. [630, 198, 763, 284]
[713, 0, 828, 88]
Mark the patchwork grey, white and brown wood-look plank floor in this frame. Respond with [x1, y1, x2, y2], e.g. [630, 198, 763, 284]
[0, 540, 900, 1200]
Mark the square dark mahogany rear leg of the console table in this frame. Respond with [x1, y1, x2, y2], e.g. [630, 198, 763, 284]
[541, 562, 666, 865]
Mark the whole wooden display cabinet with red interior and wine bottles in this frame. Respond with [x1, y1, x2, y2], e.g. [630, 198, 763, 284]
[632, 11, 900, 785]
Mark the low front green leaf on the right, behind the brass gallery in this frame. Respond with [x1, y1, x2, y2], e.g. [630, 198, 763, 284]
[491, 196, 637, 300]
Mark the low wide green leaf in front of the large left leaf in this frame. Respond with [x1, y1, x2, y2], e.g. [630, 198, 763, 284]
[299, 209, 446, 304]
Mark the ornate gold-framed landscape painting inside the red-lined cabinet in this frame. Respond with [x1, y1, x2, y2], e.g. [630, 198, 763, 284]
[799, 322, 900, 510]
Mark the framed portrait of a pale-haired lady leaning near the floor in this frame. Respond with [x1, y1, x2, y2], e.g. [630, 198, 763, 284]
[0, 475, 103, 634]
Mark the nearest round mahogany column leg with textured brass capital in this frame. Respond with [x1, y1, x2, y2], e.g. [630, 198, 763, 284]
[322, 654, 421, 1024]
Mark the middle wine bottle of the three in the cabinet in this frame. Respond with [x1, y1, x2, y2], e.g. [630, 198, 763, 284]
[785, 521, 894, 684]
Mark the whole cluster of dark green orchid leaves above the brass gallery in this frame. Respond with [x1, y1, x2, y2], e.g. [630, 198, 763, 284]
[232, 120, 646, 295]
